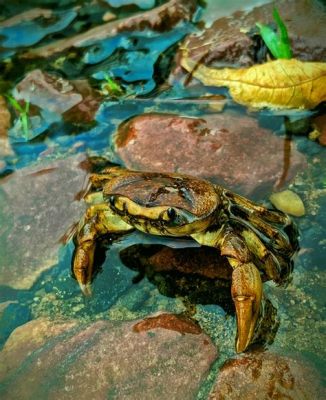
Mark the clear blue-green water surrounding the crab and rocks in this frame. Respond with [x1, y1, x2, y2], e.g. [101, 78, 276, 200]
[0, 1, 326, 398]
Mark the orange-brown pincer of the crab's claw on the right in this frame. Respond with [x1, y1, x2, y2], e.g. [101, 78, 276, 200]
[231, 263, 263, 353]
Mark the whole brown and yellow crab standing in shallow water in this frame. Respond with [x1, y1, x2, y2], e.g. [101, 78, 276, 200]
[72, 167, 298, 352]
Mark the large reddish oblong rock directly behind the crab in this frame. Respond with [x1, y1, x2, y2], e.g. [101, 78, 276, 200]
[114, 113, 306, 195]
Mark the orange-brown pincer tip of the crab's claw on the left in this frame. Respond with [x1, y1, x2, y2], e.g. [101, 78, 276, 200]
[73, 241, 95, 296]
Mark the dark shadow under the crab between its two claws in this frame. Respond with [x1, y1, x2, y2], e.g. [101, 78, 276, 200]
[92, 244, 279, 345]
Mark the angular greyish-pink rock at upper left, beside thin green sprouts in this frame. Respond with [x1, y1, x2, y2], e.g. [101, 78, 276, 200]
[14, 69, 83, 114]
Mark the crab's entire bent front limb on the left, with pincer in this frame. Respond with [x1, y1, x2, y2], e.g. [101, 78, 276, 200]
[73, 203, 133, 295]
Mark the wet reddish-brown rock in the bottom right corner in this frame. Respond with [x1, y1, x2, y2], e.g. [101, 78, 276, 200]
[209, 352, 326, 400]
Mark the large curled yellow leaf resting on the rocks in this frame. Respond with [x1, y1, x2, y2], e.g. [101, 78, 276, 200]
[181, 52, 326, 109]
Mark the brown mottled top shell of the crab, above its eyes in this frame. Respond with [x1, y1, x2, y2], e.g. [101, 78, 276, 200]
[103, 170, 218, 218]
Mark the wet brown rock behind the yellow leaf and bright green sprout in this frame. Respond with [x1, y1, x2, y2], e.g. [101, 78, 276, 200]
[171, 0, 326, 78]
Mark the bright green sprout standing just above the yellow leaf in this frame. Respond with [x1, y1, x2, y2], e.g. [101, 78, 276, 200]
[256, 7, 292, 59]
